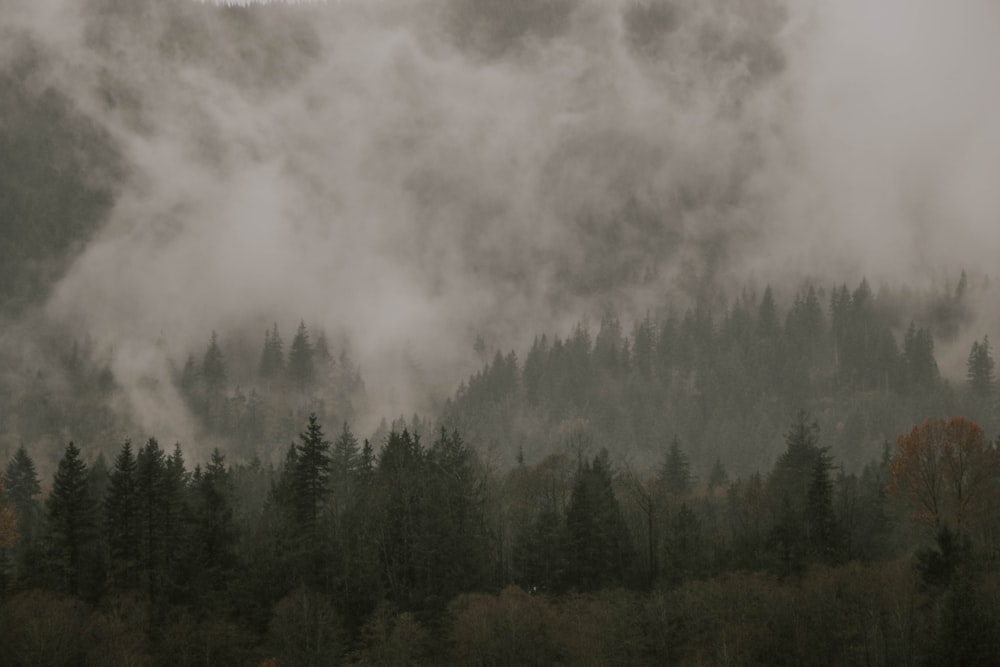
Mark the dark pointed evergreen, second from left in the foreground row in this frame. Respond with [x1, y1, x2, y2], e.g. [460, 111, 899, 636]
[46, 442, 94, 595]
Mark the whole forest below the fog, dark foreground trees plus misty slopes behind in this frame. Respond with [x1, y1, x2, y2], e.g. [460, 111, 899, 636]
[0, 284, 1000, 665]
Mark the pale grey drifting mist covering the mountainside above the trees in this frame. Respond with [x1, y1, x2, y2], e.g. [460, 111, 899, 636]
[0, 0, 1000, 440]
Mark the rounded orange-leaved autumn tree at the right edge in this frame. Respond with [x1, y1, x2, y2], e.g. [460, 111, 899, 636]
[887, 417, 1000, 531]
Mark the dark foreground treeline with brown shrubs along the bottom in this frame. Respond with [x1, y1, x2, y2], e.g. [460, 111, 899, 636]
[0, 413, 1000, 665]
